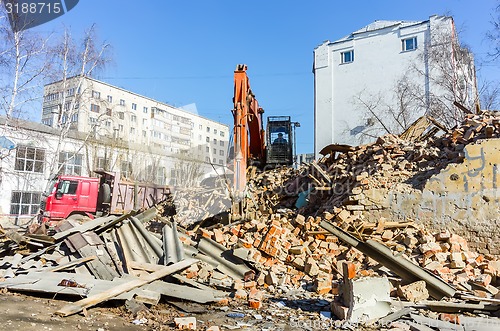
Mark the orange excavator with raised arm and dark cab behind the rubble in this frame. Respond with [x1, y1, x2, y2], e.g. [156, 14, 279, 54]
[232, 64, 293, 198]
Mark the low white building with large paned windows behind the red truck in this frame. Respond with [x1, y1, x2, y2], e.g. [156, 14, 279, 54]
[0, 117, 224, 226]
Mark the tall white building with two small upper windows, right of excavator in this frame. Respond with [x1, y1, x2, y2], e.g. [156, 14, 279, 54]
[313, 16, 477, 156]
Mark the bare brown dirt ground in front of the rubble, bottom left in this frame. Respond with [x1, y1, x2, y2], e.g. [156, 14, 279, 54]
[0, 292, 304, 331]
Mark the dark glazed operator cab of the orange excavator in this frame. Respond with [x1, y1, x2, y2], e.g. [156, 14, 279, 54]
[266, 116, 293, 167]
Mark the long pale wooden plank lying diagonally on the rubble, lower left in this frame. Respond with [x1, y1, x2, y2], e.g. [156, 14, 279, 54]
[56, 259, 198, 316]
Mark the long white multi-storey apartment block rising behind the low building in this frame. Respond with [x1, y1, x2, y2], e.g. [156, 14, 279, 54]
[42, 77, 229, 165]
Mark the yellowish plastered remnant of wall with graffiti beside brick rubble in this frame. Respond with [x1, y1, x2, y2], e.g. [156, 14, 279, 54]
[364, 139, 500, 254]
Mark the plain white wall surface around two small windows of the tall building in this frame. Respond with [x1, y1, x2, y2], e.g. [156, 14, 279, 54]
[314, 16, 458, 156]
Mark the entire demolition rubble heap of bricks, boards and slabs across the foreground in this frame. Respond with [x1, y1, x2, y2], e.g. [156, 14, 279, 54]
[0, 112, 500, 330]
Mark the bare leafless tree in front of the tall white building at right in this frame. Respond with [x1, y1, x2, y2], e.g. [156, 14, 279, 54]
[350, 17, 479, 142]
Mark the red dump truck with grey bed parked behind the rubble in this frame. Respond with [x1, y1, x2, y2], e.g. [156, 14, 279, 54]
[40, 171, 170, 225]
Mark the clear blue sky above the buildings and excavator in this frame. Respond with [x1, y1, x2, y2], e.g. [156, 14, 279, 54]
[34, 0, 499, 153]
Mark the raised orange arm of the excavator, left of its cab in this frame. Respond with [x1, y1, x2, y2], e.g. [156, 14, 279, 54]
[232, 64, 266, 197]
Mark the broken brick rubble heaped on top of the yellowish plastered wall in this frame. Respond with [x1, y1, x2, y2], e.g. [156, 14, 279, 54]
[310, 112, 500, 214]
